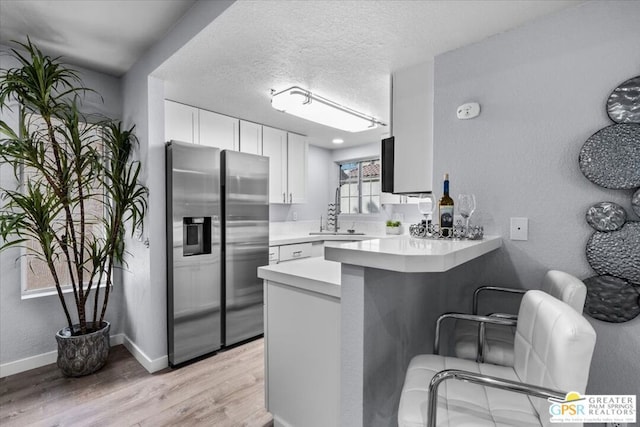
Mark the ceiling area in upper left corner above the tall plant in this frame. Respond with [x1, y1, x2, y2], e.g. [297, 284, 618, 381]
[0, 0, 195, 76]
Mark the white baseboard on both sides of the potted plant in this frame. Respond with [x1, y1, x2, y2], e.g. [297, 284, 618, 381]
[0, 334, 169, 378]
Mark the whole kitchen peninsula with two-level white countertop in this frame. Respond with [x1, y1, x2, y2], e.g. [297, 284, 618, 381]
[258, 236, 502, 426]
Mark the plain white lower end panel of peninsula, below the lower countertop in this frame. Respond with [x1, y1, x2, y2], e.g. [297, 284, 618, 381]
[264, 281, 340, 427]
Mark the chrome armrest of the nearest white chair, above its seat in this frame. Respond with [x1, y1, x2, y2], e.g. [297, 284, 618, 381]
[427, 369, 566, 427]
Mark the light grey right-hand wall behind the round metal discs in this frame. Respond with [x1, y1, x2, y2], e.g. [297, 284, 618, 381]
[434, 1, 640, 400]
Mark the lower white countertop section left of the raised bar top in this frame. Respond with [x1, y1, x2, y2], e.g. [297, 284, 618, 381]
[258, 256, 341, 298]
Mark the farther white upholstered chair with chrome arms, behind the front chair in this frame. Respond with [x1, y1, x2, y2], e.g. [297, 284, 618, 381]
[450, 270, 587, 366]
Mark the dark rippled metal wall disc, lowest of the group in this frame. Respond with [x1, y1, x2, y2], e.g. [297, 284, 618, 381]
[584, 276, 640, 323]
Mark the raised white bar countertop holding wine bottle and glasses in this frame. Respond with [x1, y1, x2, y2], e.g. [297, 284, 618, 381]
[324, 236, 502, 273]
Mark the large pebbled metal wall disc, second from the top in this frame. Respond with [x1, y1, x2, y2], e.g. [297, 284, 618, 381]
[578, 123, 640, 190]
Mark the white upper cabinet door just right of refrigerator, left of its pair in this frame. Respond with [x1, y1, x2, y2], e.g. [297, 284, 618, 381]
[262, 126, 289, 203]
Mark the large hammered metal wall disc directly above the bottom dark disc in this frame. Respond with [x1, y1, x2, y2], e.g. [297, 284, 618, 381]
[586, 221, 640, 285]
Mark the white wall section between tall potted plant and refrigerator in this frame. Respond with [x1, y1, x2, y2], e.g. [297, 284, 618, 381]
[123, 1, 233, 371]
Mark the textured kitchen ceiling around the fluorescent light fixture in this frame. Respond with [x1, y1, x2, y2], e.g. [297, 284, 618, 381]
[154, 0, 581, 148]
